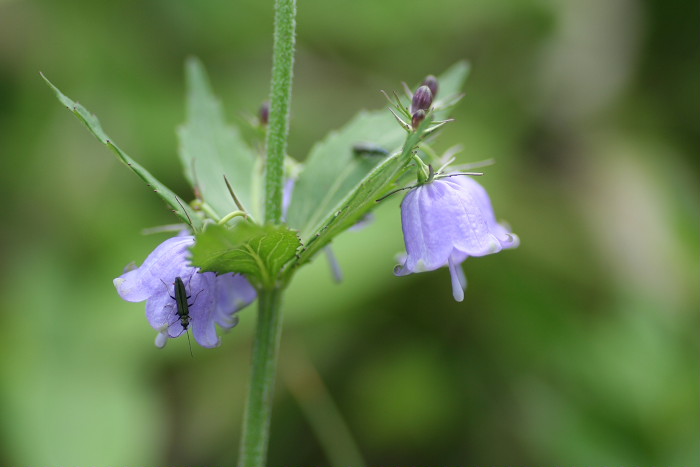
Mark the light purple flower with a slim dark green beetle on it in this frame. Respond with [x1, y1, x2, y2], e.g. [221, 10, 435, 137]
[114, 235, 257, 347]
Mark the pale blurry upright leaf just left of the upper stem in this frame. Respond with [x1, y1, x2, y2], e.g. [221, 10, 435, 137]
[178, 58, 262, 223]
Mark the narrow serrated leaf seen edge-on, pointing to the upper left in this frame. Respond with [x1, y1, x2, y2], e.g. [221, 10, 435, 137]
[41, 74, 202, 231]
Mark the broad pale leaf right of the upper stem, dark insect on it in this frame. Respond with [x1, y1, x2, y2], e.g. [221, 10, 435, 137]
[287, 62, 469, 243]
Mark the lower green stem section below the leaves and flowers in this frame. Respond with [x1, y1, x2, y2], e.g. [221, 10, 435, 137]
[238, 289, 282, 467]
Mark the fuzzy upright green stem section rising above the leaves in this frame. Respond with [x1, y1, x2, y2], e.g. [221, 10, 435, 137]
[265, 0, 296, 224]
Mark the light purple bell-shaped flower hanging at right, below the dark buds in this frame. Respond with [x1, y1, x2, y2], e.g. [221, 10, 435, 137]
[394, 176, 520, 302]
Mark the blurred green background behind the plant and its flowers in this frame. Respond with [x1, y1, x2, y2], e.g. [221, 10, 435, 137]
[0, 0, 700, 466]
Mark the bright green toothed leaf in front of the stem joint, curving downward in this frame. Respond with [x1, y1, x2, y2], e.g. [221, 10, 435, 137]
[192, 222, 301, 288]
